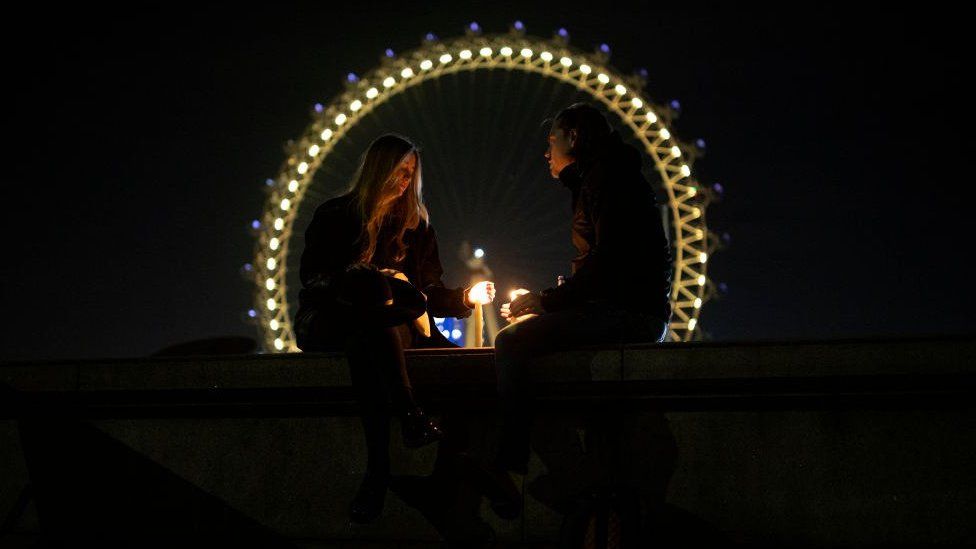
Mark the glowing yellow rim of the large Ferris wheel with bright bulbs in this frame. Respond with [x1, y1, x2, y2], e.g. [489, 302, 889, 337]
[254, 32, 712, 352]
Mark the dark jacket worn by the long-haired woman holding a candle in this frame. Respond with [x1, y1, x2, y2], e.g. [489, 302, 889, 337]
[295, 195, 471, 347]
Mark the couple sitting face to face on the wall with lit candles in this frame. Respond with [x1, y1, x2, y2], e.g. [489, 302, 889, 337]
[294, 103, 671, 522]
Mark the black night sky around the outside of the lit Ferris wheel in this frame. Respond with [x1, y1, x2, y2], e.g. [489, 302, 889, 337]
[0, 2, 976, 360]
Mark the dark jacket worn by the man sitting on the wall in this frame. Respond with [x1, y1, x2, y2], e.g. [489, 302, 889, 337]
[542, 132, 671, 321]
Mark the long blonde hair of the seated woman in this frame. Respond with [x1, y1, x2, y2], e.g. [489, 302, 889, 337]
[349, 134, 430, 263]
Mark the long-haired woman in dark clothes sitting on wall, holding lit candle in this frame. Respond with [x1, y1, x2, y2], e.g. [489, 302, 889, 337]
[295, 134, 494, 523]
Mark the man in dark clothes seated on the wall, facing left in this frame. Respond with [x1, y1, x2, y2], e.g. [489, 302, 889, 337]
[489, 103, 671, 518]
